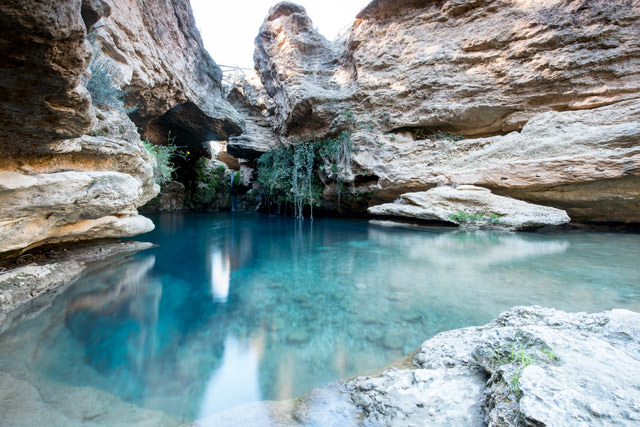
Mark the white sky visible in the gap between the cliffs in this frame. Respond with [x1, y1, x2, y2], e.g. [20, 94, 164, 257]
[191, 0, 370, 68]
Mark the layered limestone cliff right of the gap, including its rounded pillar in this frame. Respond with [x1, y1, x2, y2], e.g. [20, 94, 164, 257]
[254, 0, 640, 222]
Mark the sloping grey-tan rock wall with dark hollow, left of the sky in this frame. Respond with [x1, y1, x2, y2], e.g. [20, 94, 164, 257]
[92, 0, 244, 154]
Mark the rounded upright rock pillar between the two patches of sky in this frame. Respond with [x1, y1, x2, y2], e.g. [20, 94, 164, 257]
[253, 2, 354, 137]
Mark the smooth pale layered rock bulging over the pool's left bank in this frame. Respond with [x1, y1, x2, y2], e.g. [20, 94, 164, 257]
[0, 105, 158, 252]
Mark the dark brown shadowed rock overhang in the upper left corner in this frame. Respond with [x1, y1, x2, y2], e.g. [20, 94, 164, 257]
[0, 0, 93, 152]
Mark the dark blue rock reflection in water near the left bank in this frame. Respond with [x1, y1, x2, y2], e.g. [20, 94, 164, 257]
[65, 256, 162, 393]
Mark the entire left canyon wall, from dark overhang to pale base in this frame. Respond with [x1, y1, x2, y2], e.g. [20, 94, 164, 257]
[0, 0, 244, 252]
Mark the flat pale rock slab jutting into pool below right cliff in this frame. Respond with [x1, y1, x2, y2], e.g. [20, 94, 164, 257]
[368, 185, 570, 230]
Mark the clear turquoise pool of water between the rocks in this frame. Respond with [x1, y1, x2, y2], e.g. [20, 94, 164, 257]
[0, 213, 640, 422]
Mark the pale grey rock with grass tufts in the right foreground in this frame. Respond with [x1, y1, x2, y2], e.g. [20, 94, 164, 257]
[193, 306, 640, 426]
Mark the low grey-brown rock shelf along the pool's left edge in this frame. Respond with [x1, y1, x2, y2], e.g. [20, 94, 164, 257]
[0, 241, 153, 333]
